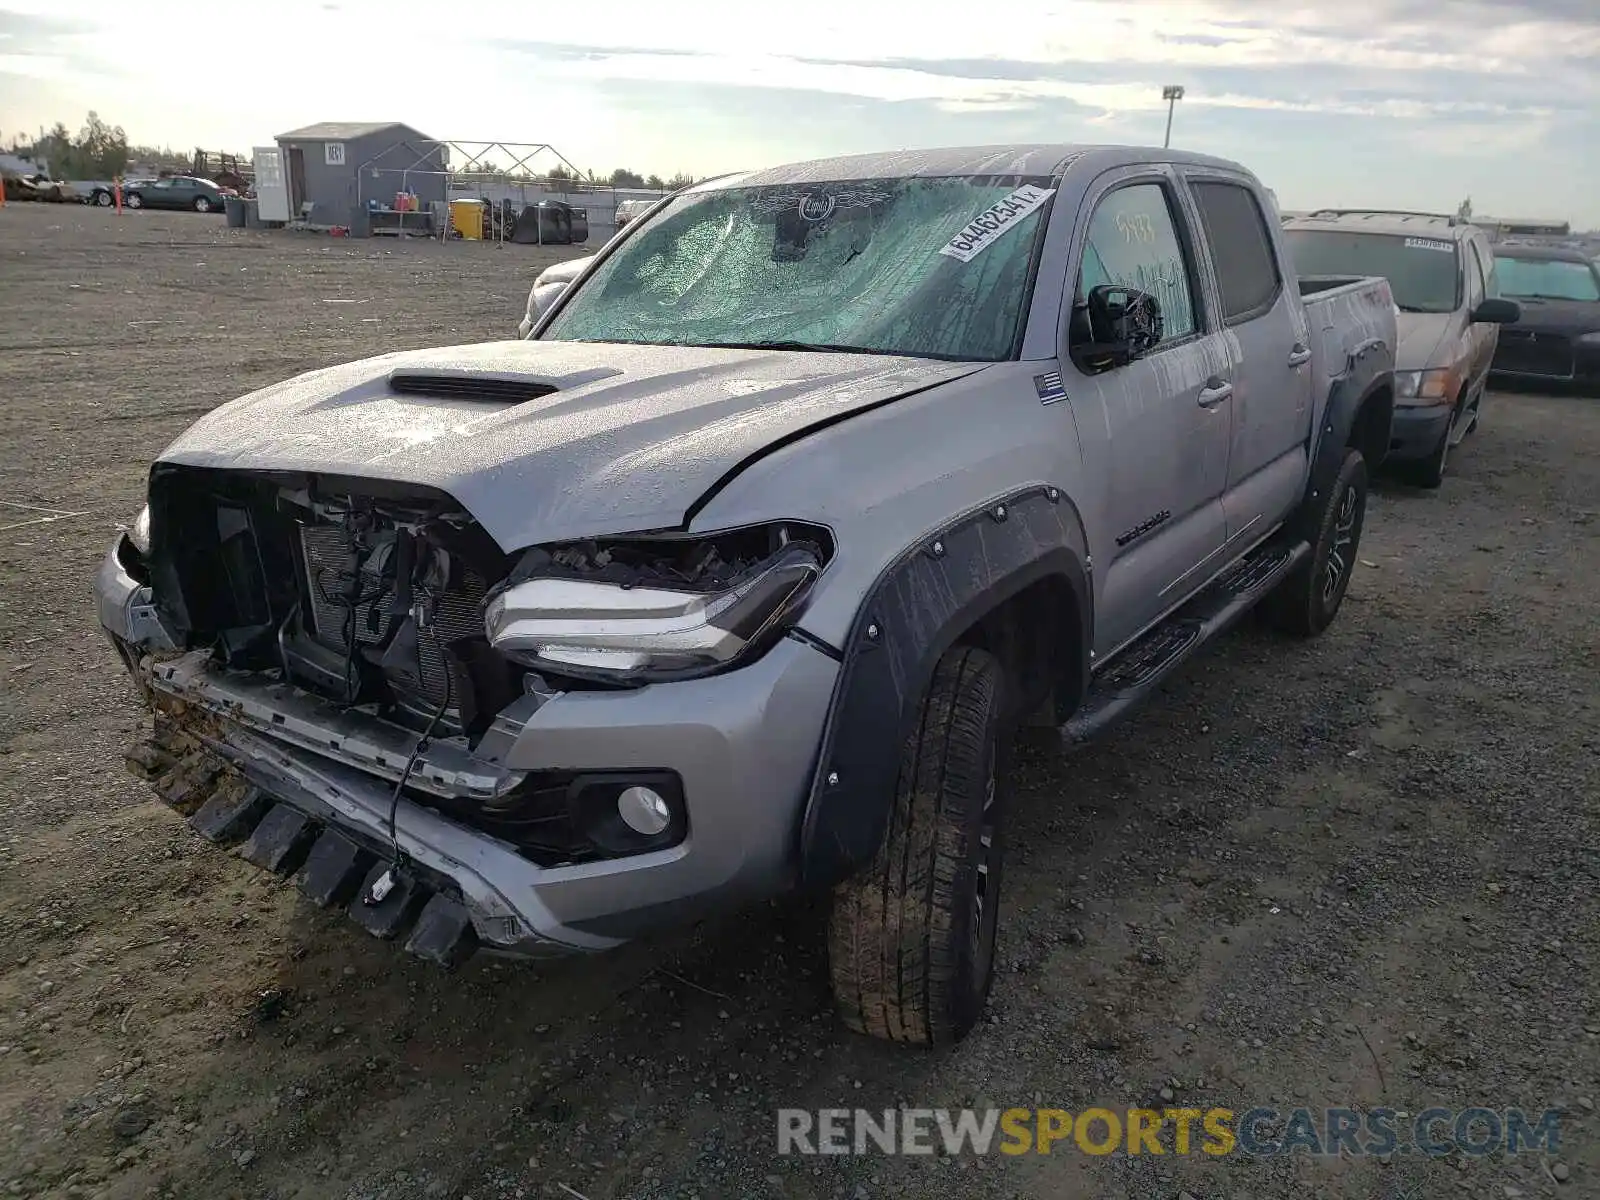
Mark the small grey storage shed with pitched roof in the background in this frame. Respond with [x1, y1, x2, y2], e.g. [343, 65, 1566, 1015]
[275, 122, 448, 226]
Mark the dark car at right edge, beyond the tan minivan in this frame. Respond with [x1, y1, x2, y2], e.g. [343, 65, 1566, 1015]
[1494, 245, 1600, 390]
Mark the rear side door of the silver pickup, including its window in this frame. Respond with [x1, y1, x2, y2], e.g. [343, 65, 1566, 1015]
[1189, 173, 1312, 554]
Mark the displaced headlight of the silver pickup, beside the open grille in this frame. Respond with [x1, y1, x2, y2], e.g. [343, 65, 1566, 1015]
[483, 534, 826, 683]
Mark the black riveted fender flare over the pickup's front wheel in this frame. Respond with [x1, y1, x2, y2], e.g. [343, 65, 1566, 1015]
[798, 485, 1094, 886]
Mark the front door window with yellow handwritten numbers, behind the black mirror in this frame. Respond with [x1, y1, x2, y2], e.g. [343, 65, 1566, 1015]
[1077, 184, 1197, 346]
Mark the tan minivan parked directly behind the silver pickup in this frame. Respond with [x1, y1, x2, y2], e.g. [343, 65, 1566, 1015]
[1286, 210, 1518, 488]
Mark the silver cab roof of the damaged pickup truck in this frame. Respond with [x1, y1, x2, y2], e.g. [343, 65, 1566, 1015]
[693, 142, 1248, 190]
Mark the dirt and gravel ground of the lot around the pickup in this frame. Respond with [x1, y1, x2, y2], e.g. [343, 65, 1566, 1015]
[0, 206, 1600, 1200]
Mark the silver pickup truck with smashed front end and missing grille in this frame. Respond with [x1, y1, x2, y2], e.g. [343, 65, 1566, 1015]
[98, 146, 1395, 1043]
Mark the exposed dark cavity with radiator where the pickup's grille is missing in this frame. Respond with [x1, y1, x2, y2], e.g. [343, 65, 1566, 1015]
[149, 467, 522, 731]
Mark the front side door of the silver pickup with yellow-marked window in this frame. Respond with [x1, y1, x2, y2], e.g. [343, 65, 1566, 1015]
[1062, 168, 1229, 659]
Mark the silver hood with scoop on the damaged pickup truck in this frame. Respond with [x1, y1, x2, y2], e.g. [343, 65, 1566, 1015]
[158, 341, 984, 550]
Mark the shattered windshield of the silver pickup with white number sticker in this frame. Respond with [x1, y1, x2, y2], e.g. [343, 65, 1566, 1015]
[541, 176, 1054, 362]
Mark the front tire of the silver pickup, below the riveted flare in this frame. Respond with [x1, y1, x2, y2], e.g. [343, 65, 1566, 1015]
[827, 646, 1010, 1045]
